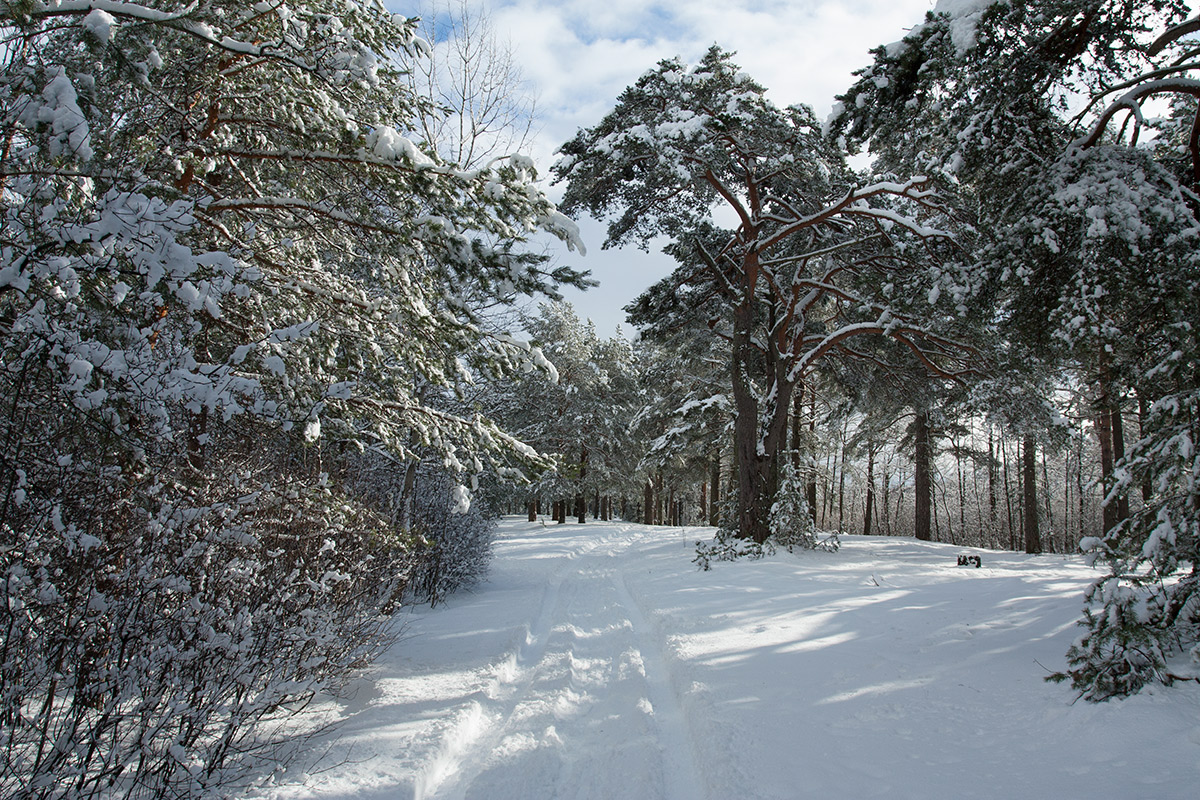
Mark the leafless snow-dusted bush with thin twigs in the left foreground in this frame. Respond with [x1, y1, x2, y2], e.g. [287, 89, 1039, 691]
[0, 448, 412, 798]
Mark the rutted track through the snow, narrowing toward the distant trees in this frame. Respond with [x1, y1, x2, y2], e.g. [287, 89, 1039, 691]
[414, 525, 702, 800]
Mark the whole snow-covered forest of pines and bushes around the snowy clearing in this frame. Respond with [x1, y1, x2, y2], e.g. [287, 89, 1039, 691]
[0, 0, 1200, 798]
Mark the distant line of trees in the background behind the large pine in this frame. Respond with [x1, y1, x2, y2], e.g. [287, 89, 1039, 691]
[492, 303, 1104, 553]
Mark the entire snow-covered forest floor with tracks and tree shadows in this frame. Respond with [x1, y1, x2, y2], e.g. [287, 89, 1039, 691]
[254, 519, 1200, 800]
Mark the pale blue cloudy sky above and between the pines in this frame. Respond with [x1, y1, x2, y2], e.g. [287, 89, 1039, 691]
[388, 0, 934, 337]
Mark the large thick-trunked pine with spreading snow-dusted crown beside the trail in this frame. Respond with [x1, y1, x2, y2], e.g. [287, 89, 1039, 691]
[554, 47, 979, 542]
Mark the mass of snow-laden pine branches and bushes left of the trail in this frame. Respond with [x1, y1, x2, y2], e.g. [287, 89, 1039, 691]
[0, 0, 583, 798]
